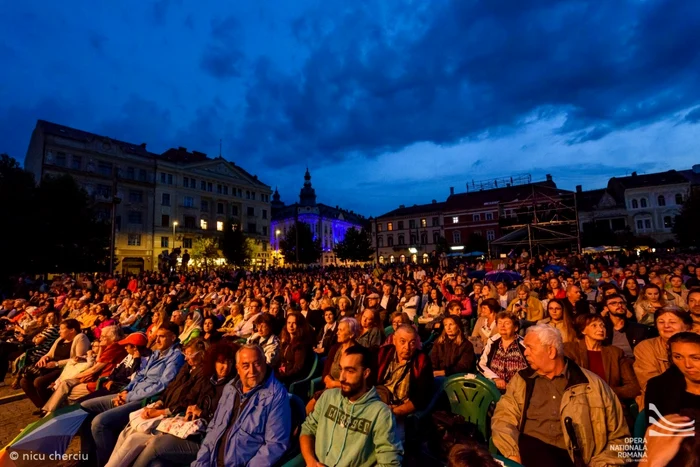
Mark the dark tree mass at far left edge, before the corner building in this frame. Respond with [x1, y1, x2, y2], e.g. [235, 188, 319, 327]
[0, 154, 110, 280]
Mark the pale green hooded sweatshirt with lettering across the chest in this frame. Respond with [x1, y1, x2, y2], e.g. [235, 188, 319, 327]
[301, 387, 403, 467]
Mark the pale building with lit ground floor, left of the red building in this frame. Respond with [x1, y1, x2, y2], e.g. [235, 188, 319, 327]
[371, 200, 445, 264]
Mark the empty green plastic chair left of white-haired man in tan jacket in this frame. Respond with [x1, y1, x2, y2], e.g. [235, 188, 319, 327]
[443, 375, 501, 440]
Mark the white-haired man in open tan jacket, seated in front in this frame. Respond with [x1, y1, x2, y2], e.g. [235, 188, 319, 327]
[491, 324, 629, 467]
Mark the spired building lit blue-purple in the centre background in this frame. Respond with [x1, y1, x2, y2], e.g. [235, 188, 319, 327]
[269, 169, 367, 266]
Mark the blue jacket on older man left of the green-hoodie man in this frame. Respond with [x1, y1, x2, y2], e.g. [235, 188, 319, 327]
[191, 372, 292, 467]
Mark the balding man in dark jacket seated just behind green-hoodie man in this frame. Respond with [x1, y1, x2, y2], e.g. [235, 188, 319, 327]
[377, 324, 434, 439]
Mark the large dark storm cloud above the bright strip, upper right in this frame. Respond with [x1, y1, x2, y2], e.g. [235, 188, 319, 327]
[234, 0, 700, 165]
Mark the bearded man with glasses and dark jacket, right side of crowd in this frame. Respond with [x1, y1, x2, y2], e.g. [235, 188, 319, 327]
[602, 294, 651, 358]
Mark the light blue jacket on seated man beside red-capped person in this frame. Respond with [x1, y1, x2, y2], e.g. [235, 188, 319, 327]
[124, 347, 185, 402]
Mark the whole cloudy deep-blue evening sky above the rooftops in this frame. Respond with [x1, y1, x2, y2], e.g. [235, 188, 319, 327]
[0, 0, 700, 216]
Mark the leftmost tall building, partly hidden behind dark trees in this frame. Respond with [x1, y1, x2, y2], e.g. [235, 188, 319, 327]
[25, 120, 157, 271]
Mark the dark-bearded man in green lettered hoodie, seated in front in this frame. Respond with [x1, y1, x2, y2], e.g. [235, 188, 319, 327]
[299, 345, 403, 467]
